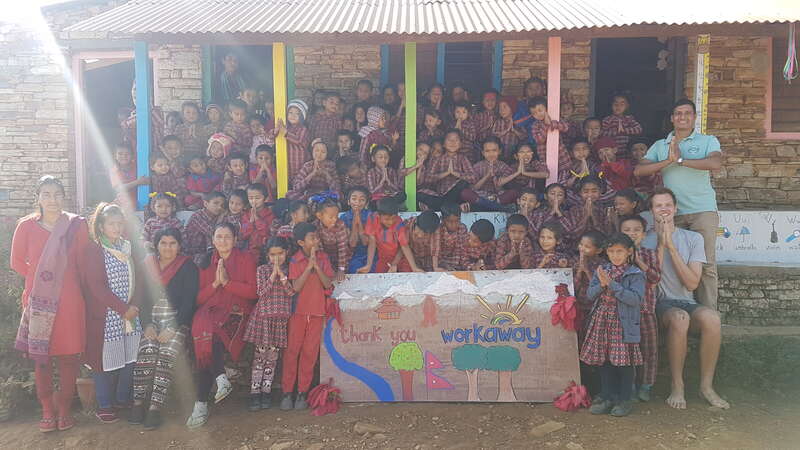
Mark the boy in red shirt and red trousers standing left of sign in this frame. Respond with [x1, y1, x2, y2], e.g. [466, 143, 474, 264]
[281, 223, 333, 411]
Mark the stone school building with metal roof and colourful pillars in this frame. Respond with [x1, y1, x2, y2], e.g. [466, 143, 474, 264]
[0, 0, 800, 324]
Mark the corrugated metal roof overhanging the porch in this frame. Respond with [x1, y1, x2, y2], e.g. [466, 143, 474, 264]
[67, 0, 800, 35]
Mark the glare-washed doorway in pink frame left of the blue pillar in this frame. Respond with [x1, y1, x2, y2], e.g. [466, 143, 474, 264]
[83, 59, 135, 206]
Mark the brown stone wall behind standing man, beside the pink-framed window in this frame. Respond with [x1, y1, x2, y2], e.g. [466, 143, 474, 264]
[686, 36, 800, 209]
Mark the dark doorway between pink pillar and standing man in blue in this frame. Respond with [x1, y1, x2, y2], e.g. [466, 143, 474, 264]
[592, 38, 686, 141]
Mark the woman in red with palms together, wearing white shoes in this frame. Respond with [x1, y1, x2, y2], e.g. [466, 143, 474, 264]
[186, 223, 258, 428]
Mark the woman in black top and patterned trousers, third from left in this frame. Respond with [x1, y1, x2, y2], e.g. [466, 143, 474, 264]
[128, 228, 199, 430]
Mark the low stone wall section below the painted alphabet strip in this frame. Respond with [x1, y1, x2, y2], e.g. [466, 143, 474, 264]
[719, 266, 800, 325]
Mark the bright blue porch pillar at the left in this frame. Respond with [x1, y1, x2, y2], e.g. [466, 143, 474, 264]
[133, 41, 153, 209]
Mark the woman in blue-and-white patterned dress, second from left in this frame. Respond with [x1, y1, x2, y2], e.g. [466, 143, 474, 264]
[86, 203, 142, 423]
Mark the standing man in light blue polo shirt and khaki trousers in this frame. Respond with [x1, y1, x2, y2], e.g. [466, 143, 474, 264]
[633, 98, 722, 310]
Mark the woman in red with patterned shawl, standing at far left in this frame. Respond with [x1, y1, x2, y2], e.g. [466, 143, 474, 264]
[11, 176, 138, 432]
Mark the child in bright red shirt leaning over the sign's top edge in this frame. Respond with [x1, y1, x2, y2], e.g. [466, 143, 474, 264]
[358, 198, 423, 273]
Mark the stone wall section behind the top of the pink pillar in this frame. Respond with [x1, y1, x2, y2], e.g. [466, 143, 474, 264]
[503, 39, 592, 119]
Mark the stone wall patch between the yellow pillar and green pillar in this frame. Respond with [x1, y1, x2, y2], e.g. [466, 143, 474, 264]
[294, 45, 381, 106]
